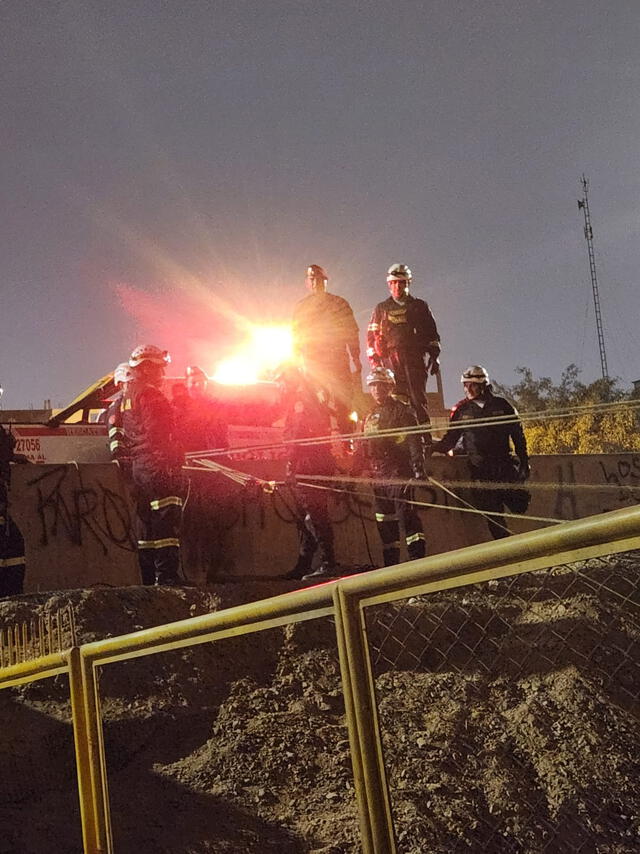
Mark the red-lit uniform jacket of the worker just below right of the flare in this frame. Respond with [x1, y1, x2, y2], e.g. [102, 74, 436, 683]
[284, 384, 336, 475]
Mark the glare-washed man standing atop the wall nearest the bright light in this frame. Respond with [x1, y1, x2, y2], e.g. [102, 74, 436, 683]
[292, 264, 362, 442]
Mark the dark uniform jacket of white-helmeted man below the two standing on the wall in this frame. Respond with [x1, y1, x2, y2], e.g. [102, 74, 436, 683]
[354, 397, 423, 477]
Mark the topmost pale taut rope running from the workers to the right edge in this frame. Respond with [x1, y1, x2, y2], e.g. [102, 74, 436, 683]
[185, 399, 640, 460]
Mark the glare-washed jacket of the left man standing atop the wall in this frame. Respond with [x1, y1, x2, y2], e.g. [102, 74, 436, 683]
[293, 293, 360, 365]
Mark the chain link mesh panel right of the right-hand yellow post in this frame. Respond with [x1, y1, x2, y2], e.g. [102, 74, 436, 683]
[365, 552, 640, 854]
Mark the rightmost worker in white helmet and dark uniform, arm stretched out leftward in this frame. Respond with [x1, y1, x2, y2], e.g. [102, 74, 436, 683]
[432, 365, 530, 539]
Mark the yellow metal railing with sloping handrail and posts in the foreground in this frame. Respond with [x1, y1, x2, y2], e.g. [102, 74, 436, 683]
[0, 507, 640, 854]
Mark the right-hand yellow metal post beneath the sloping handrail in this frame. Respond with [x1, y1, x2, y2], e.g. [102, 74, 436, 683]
[333, 582, 396, 854]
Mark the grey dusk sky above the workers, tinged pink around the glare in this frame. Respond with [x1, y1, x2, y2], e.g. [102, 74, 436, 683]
[0, 0, 640, 408]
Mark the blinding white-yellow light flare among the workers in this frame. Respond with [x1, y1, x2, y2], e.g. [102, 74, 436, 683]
[213, 324, 293, 385]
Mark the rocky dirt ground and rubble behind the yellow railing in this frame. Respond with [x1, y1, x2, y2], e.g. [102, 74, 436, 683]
[0, 555, 640, 854]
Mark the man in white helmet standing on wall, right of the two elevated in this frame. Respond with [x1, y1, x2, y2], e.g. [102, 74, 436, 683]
[367, 264, 440, 428]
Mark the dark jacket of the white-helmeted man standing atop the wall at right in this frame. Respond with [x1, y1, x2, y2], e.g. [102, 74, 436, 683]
[367, 295, 440, 364]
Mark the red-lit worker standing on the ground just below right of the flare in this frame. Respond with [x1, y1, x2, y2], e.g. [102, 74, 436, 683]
[281, 369, 340, 580]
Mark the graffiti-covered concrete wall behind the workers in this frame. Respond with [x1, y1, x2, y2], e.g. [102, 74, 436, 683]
[10, 454, 640, 592]
